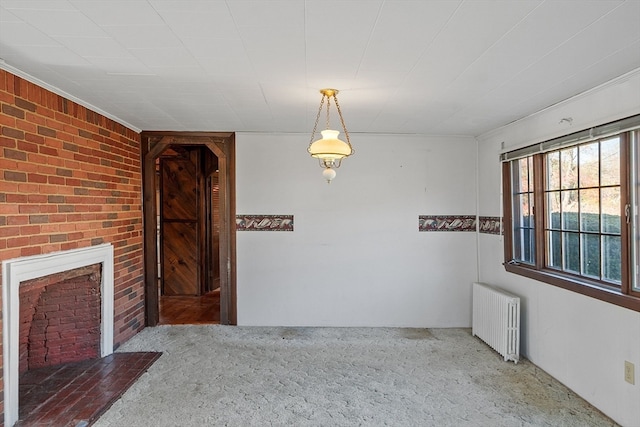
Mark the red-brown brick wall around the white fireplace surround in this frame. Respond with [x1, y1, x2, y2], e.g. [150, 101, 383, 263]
[0, 70, 144, 418]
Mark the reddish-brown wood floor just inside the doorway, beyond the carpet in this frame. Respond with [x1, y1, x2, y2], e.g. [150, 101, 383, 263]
[160, 288, 220, 325]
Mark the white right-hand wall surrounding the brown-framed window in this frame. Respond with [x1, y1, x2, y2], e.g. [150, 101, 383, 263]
[478, 70, 640, 426]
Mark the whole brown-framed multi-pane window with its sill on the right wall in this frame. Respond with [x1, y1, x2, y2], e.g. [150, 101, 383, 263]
[503, 116, 640, 311]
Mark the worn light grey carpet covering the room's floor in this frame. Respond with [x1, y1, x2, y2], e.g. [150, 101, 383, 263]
[95, 325, 616, 427]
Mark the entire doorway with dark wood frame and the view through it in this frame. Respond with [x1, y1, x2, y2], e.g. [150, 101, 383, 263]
[142, 132, 236, 326]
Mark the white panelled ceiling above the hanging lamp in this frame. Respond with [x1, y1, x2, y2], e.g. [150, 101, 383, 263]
[0, 0, 640, 135]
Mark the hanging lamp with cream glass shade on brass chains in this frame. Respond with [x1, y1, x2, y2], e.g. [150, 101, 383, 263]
[307, 89, 354, 184]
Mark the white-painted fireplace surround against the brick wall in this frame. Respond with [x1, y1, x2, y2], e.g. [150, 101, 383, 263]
[2, 244, 114, 426]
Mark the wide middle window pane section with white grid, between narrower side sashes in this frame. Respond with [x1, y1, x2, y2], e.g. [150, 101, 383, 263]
[544, 136, 622, 286]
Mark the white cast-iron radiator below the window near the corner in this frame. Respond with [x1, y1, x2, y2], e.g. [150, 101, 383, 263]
[471, 283, 520, 363]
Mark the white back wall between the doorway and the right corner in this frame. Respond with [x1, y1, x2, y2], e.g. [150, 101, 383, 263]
[236, 133, 477, 327]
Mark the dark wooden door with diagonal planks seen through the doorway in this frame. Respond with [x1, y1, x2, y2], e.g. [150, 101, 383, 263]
[160, 150, 202, 296]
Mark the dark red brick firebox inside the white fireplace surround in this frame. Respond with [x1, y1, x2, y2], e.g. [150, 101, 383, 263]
[19, 264, 102, 373]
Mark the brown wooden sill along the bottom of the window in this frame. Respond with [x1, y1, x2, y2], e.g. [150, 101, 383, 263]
[504, 264, 640, 312]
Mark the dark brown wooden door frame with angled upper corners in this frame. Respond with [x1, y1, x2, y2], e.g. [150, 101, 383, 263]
[140, 131, 237, 326]
